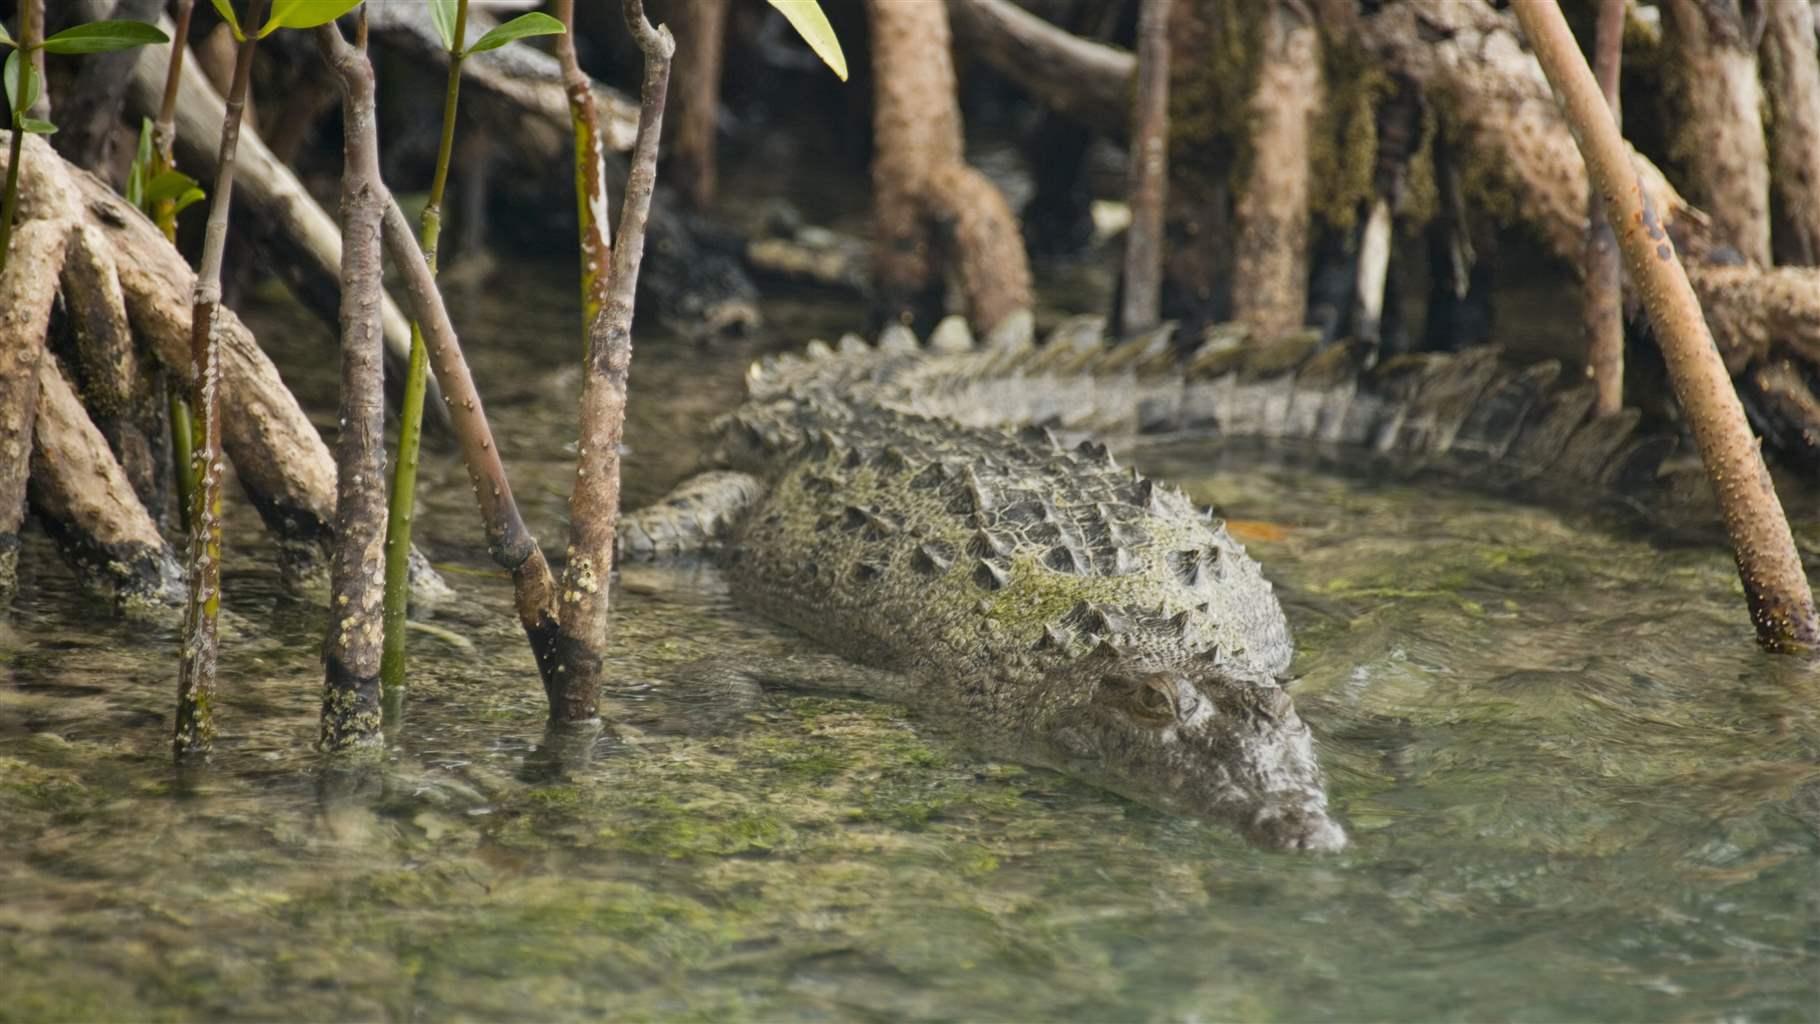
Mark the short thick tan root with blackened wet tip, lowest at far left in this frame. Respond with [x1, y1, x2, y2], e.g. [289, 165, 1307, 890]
[31, 358, 184, 620]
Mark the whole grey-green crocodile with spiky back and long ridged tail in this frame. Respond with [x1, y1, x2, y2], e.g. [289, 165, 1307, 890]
[619, 315, 1710, 849]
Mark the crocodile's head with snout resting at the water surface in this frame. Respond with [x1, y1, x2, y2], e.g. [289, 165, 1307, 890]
[1045, 658, 1347, 851]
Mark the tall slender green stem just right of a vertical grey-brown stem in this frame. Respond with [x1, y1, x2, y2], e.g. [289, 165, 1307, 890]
[379, 0, 468, 702]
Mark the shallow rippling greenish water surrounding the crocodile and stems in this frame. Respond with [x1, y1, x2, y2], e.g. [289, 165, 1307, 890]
[0, 269, 1820, 1020]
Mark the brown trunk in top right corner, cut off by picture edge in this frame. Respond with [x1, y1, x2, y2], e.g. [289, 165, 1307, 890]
[1762, 0, 1820, 266]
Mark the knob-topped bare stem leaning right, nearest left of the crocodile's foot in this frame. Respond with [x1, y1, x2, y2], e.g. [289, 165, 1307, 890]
[548, 0, 675, 722]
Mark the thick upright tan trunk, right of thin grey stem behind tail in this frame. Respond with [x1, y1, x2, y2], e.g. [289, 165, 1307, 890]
[1232, 0, 1323, 335]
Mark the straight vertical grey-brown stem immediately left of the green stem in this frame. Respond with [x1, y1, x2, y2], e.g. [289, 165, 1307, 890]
[317, 22, 386, 749]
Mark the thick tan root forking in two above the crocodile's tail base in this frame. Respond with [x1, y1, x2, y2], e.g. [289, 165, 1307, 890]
[866, 0, 1033, 327]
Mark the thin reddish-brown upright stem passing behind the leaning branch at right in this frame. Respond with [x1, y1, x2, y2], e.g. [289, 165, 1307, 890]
[1582, 0, 1623, 417]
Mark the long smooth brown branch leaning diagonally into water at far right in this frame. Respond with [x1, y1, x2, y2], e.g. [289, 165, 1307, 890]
[1516, 0, 1820, 649]
